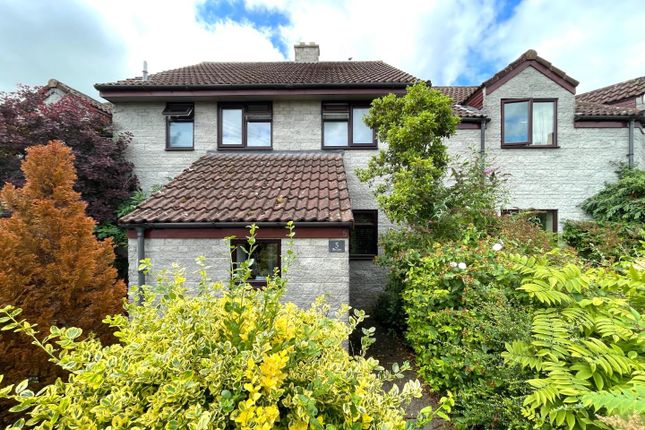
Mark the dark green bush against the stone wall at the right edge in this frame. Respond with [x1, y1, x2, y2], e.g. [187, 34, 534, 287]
[582, 165, 645, 224]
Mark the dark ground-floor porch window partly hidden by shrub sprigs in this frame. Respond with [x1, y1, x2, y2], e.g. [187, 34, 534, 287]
[233, 239, 280, 286]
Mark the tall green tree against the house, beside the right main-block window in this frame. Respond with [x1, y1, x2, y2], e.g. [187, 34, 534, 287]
[358, 82, 459, 227]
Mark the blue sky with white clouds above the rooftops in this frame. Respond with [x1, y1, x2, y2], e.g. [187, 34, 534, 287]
[0, 0, 645, 97]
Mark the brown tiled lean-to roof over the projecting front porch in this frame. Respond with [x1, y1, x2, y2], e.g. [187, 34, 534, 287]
[120, 152, 353, 224]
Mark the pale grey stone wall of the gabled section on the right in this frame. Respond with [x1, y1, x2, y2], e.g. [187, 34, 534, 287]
[449, 67, 628, 231]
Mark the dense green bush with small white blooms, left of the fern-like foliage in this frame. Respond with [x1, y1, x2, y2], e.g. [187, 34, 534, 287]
[403, 238, 530, 429]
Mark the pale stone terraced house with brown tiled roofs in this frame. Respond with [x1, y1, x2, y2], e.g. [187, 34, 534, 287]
[96, 44, 645, 310]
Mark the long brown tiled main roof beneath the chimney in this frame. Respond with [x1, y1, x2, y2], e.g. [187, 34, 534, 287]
[94, 61, 418, 90]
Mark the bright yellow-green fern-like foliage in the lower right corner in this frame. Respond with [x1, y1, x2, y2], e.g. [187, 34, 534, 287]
[503, 257, 645, 430]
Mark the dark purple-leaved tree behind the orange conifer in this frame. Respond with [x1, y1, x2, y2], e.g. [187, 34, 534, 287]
[0, 87, 138, 223]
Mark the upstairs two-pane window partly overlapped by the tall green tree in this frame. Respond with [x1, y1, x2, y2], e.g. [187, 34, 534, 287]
[322, 102, 376, 149]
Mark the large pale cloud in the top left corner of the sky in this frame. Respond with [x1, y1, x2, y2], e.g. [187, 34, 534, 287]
[0, 0, 127, 97]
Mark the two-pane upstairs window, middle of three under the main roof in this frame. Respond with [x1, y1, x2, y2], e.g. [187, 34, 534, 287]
[217, 103, 273, 149]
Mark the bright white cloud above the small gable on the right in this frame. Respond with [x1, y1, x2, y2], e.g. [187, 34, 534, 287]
[481, 0, 645, 93]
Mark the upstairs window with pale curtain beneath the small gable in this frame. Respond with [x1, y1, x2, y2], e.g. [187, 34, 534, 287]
[502, 99, 557, 148]
